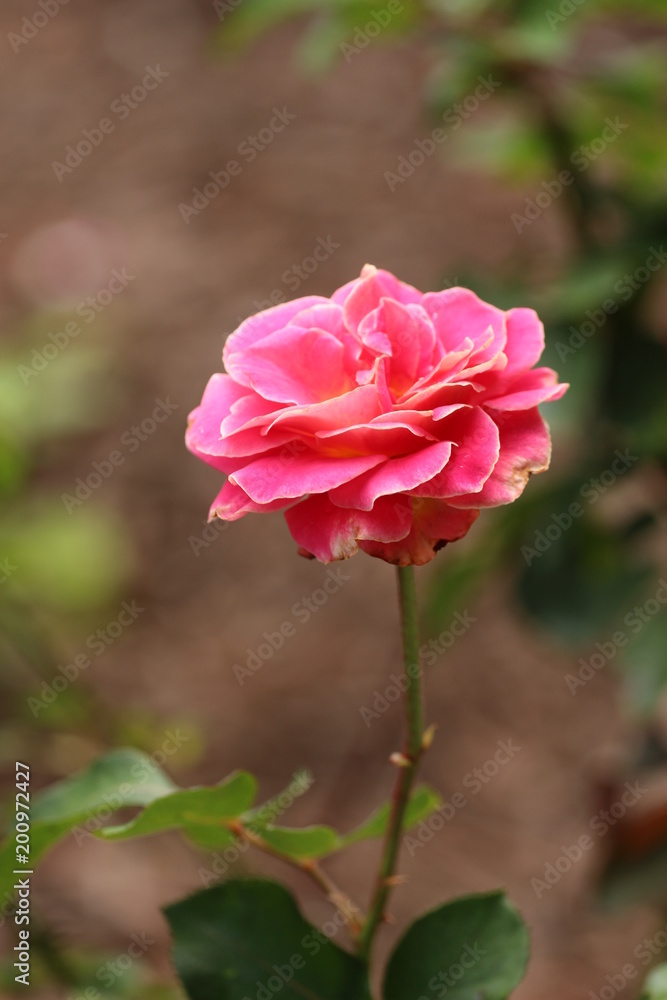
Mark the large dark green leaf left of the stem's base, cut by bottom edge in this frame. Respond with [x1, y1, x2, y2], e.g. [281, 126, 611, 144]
[165, 879, 374, 1000]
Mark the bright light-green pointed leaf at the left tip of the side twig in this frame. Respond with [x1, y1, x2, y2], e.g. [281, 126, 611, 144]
[98, 771, 257, 847]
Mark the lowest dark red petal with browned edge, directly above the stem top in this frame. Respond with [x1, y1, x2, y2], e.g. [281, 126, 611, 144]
[360, 497, 479, 566]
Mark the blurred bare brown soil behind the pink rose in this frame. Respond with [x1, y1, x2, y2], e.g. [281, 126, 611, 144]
[0, 0, 658, 1000]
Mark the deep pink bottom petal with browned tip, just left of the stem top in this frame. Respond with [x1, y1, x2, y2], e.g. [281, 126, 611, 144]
[285, 495, 412, 563]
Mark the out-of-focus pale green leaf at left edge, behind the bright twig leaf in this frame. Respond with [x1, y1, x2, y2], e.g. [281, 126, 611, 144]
[0, 748, 176, 892]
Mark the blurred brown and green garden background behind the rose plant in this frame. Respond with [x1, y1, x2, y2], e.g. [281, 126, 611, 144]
[0, 0, 667, 1000]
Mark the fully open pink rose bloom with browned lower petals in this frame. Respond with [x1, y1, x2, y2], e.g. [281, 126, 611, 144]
[186, 265, 567, 566]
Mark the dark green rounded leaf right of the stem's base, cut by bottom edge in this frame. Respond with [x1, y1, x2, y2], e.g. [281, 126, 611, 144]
[384, 892, 529, 1000]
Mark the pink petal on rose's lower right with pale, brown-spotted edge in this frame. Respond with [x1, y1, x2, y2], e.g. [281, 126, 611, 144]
[449, 407, 551, 507]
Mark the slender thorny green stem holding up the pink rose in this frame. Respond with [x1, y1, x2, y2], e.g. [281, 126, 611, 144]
[359, 566, 426, 961]
